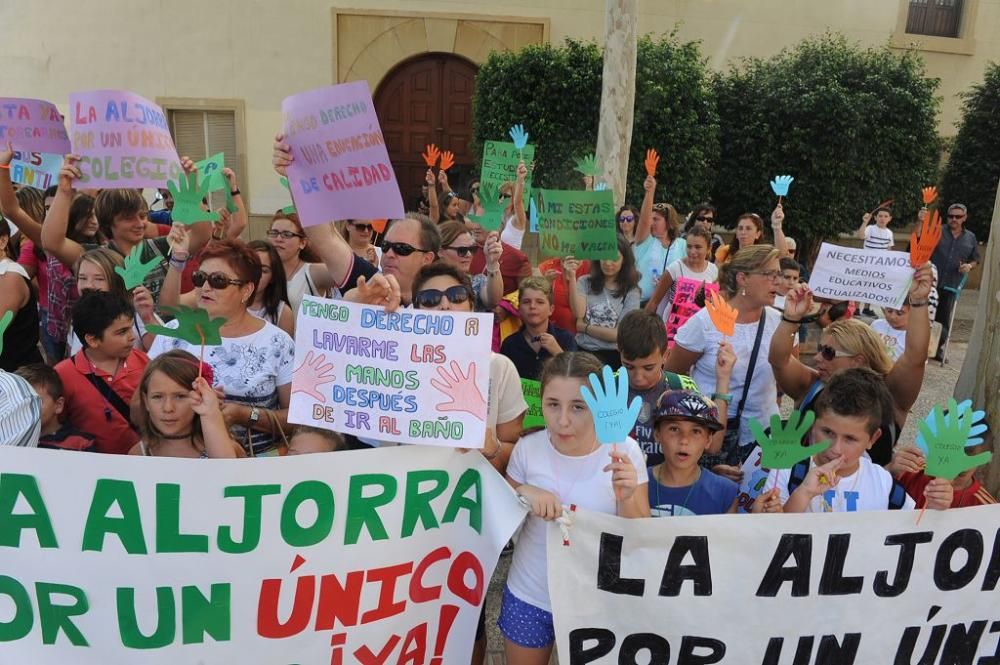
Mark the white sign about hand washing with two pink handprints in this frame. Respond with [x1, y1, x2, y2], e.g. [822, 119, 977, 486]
[288, 295, 493, 448]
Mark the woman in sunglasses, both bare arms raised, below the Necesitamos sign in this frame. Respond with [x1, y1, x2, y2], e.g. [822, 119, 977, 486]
[768, 264, 933, 465]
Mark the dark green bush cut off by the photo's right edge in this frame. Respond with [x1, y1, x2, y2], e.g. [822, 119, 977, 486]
[941, 63, 1000, 242]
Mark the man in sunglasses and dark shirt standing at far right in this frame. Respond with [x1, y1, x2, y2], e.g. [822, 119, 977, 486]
[931, 203, 980, 362]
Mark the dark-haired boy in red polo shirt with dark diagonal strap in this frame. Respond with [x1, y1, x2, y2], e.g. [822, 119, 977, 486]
[56, 292, 149, 455]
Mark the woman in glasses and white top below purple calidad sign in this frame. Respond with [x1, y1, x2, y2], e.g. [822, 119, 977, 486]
[267, 210, 337, 312]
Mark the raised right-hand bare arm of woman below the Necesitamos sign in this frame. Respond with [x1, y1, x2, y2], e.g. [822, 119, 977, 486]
[885, 263, 934, 421]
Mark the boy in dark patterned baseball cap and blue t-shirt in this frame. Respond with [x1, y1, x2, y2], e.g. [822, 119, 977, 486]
[647, 390, 738, 517]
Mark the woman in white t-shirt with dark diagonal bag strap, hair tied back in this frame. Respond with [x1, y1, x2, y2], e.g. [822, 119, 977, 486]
[666, 245, 791, 483]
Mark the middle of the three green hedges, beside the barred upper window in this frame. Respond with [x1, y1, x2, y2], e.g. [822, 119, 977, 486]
[714, 34, 939, 252]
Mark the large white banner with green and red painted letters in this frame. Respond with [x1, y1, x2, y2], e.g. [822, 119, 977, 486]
[0, 446, 524, 665]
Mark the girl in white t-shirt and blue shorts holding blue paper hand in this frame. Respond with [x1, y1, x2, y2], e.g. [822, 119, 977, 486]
[497, 352, 649, 665]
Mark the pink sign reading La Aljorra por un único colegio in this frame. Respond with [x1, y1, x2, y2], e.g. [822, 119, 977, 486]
[69, 90, 181, 188]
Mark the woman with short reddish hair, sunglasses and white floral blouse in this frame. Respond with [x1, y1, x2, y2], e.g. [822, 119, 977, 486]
[149, 240, 295, 456]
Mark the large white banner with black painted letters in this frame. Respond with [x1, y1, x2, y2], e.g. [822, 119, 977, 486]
[548, 506, 1000, 665]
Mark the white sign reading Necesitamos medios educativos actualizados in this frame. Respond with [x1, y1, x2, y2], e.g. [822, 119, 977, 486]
[809, 242, 913, 309]
